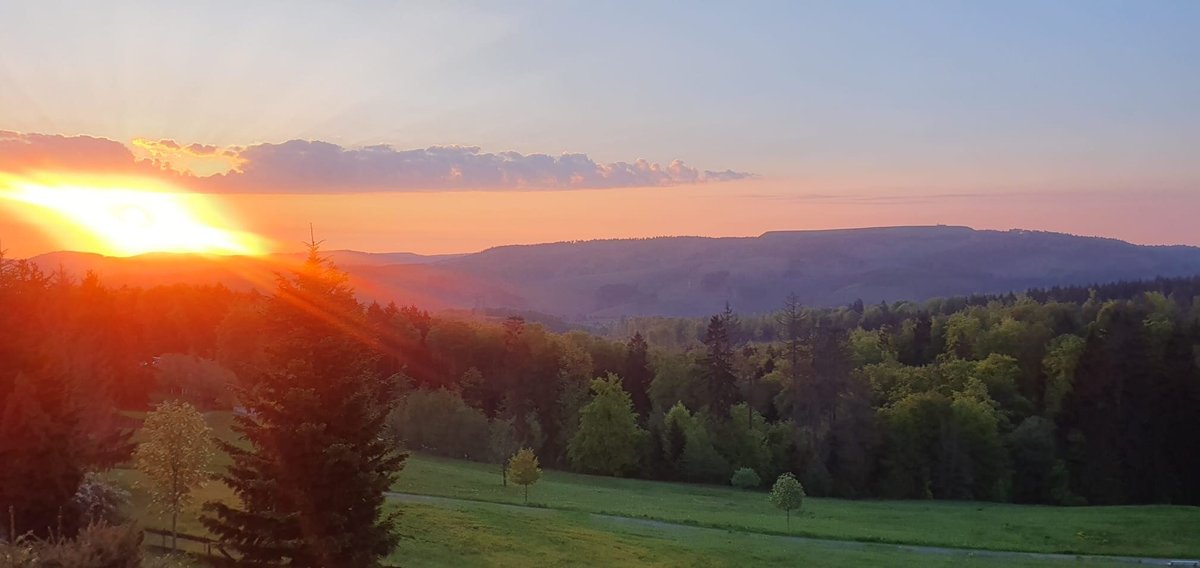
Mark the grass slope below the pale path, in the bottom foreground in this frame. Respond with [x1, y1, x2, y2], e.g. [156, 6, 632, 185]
[389, 494, 1112, 568]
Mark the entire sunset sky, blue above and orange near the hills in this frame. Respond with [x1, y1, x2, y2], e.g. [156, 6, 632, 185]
[0, 0, 1200, 256]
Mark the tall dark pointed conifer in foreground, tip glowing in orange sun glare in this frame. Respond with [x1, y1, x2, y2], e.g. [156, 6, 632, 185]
[204, 244, 407, 568]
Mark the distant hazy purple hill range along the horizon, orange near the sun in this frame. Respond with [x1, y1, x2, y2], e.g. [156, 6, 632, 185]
[23, 226, 1200, 319]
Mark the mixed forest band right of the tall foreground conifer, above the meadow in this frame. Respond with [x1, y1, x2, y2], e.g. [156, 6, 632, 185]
[374, 285, 1200, 504]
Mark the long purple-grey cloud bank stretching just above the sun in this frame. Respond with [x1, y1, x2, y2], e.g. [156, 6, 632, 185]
[0, 131, 752, 193]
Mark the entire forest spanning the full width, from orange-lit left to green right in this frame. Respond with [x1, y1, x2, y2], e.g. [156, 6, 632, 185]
[0, 246, 1200, 550]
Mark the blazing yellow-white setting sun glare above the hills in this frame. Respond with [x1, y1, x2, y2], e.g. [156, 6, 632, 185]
[0, 174, 264, 256]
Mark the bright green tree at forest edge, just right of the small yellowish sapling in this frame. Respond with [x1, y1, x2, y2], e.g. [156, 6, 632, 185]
[566, 373, 644, 476]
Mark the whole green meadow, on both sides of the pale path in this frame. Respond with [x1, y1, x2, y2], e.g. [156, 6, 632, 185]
[113, 413, 1200, 567]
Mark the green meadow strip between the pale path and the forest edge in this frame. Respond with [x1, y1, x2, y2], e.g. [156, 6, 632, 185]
[396, 455, 1200, 557]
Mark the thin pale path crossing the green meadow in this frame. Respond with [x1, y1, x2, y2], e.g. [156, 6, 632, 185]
[388, 492, 1200, 568]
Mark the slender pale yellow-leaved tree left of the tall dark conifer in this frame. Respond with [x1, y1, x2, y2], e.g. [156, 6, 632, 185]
[134, 401, 215, 550]
